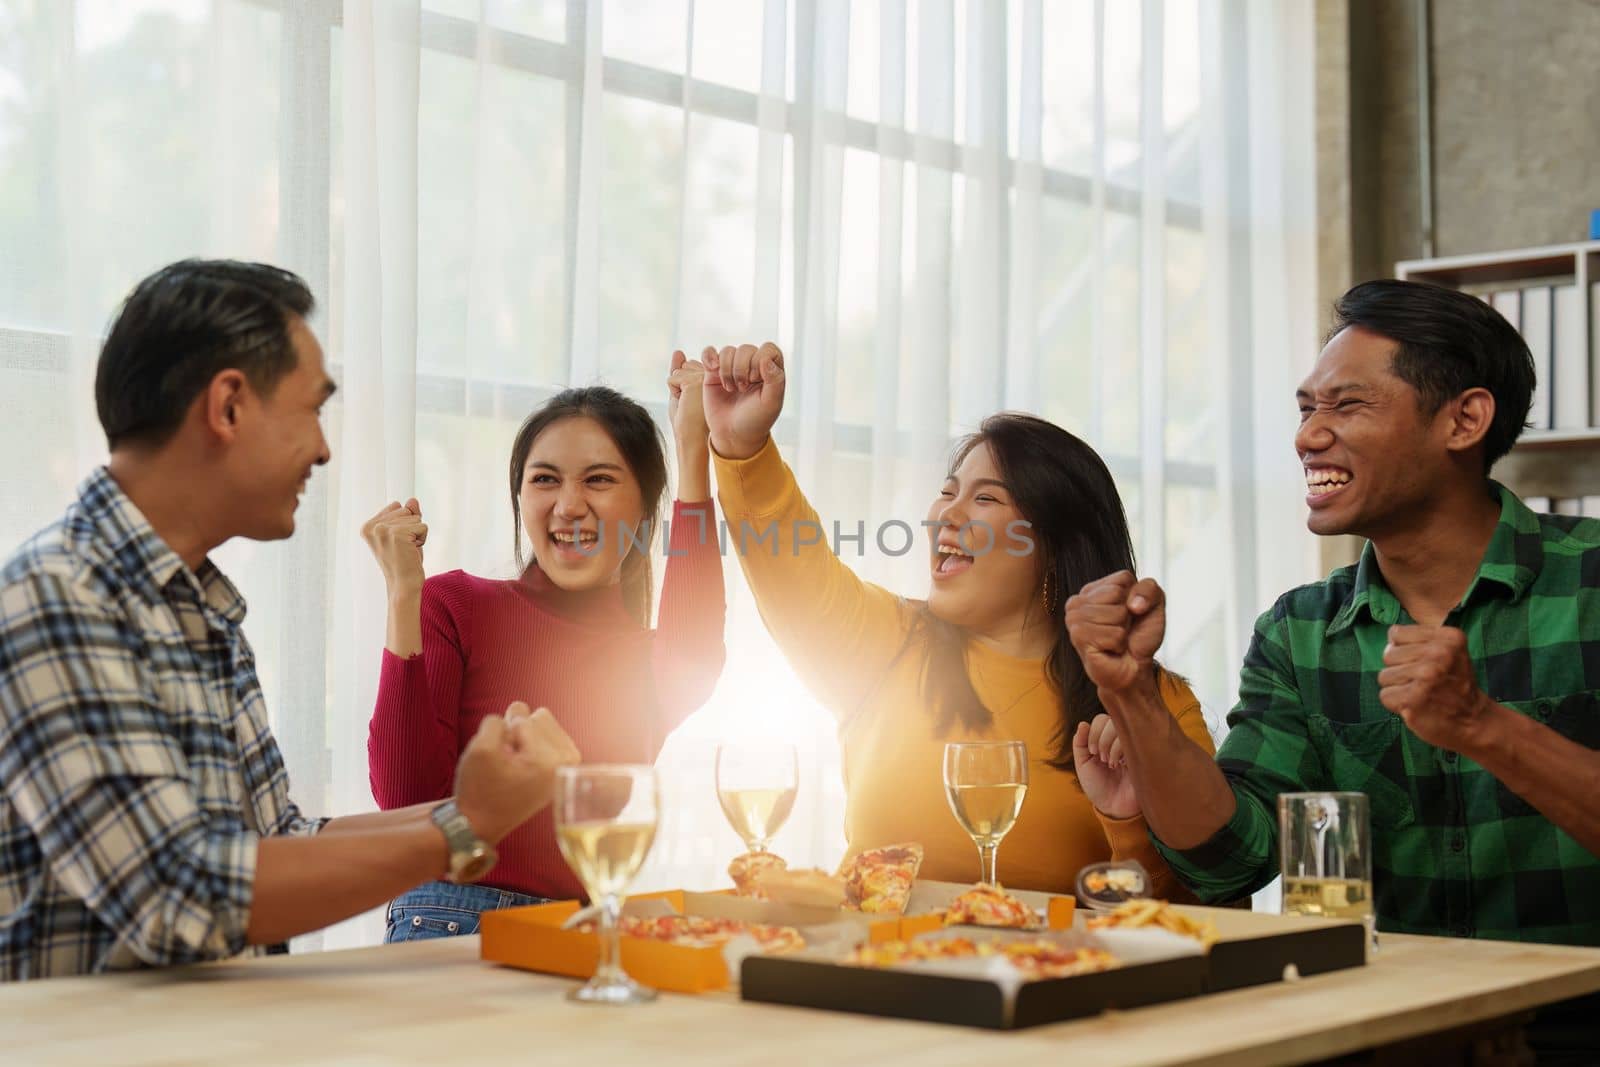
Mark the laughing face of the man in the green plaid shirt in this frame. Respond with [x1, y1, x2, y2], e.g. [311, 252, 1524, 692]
[1294, 326, 1454, 537]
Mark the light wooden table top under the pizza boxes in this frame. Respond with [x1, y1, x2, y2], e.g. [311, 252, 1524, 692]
[9, 934, 1600, 1067]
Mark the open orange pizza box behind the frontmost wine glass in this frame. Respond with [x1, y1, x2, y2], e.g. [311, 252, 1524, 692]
[478, 889, 901, 993]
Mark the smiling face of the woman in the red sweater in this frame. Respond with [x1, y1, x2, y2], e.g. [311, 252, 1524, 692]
[518, 416, 645, 592]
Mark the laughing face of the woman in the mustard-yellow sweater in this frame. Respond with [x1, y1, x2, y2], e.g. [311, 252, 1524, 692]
[928, 443, 1042, 632]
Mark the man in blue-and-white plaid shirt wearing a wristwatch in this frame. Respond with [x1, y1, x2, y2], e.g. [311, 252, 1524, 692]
[0, 261, 578, 979]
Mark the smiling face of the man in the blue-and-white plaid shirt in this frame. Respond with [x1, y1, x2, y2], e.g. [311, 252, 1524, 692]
[227, 315, 334, 541]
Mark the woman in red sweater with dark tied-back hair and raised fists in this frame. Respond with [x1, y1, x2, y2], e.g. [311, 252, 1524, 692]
[362, 352, 726, 941]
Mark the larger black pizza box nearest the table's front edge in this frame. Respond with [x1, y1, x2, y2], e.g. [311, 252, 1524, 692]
[739, 928, 1206, 1030]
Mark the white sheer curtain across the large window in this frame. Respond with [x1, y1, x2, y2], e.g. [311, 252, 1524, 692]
[0, 0, 1317, 945]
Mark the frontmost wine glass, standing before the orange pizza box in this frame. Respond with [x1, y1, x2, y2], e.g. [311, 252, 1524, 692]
[555, 763, 659, 1005]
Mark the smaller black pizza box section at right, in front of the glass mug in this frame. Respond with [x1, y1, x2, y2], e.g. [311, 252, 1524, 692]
[1174, 904, 1368, 993]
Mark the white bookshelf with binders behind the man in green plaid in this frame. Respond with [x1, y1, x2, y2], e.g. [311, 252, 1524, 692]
[1395, 240, 1600, 515]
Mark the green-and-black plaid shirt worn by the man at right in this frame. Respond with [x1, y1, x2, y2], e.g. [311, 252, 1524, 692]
[1157, 485, 1600, 945]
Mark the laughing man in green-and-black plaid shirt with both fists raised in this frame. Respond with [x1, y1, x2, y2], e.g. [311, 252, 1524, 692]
[1067, 282, 1600, 945]
